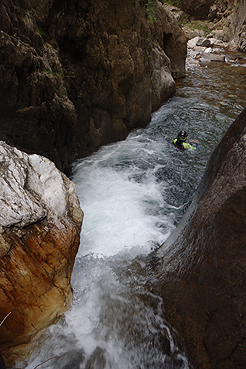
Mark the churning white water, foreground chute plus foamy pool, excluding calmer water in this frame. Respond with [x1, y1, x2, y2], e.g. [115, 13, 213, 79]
[27, 124, 188, 369]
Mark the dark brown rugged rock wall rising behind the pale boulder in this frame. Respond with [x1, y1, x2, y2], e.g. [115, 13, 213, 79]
[0, 0, 186, 169]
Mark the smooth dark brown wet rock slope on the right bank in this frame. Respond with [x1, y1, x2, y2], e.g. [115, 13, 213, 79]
[147, 110, 246, 369]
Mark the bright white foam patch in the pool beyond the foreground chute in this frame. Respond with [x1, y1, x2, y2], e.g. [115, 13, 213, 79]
[73, 135, 176, 256]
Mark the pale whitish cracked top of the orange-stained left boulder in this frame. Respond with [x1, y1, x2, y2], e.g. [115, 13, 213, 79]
[0, 142, 71, 227]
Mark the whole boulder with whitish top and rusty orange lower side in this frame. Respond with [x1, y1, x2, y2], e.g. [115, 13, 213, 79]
[0, 142, 83, 363]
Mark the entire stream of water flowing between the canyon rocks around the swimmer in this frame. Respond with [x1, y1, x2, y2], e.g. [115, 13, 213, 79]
[26, 50, 246, 369]
